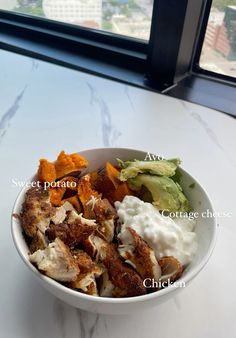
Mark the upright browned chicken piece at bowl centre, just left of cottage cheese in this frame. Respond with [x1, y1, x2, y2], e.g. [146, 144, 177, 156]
[87, 196, 117, 243]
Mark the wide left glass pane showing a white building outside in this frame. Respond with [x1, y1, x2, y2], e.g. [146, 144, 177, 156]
[0, 0, 153, 40]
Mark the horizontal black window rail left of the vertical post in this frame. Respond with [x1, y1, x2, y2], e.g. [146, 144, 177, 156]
[0, 10, 148, 85]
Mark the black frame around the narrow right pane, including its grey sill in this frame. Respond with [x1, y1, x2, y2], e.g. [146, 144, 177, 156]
[167, 0, 236, 118]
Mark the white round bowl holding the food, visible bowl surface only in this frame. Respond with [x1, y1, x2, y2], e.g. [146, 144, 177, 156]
[12, 148, 217, 314]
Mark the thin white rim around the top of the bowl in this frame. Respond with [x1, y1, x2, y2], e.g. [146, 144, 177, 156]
[11, 147, 218, 304]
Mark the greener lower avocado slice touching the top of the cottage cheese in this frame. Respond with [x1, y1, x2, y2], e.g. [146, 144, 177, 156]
[128, 174, 190, 212]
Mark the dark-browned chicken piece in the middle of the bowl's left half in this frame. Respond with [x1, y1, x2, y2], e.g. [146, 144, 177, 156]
[46, 215, 97, 248]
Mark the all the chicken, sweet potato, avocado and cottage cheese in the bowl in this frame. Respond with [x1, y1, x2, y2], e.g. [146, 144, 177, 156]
[16, 151, 197, 298]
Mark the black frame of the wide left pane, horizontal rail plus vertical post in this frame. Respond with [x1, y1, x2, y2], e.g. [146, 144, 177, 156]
[0, 0, 194, 91]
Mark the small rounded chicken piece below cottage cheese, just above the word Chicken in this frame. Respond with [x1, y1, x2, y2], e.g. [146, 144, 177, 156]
[158, 256, 183, 283]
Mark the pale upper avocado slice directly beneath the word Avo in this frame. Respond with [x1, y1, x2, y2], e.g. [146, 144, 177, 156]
[118, 159, 180, 181]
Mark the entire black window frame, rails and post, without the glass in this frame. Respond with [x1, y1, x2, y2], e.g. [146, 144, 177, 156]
[0, 0, 236, 115]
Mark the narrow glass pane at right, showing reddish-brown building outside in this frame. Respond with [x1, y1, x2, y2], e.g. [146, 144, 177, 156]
[200, 0, 236, 77]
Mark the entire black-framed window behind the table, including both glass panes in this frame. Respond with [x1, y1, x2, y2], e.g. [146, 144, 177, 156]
[0, 0, 236, 115]
